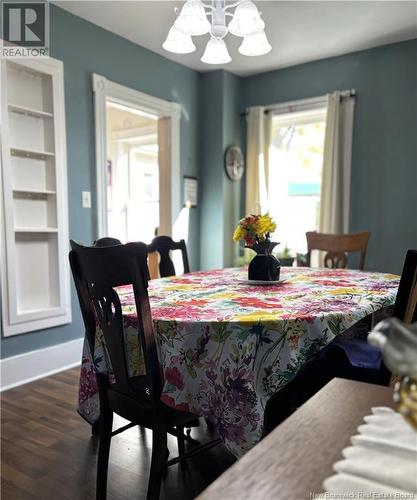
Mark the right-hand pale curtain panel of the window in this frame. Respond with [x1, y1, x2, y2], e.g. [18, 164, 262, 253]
[319, 91, 355, 234]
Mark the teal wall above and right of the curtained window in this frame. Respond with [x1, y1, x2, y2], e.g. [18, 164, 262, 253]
[241, 40, 417, 273]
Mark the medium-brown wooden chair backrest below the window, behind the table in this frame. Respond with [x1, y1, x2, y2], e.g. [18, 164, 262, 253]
[306, 231, 371, 271]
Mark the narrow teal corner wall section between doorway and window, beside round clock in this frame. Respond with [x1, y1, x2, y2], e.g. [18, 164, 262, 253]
[200, 70, 242, 269]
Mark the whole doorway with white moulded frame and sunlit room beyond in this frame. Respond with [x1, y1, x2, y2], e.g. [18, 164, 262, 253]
[93, 75, 181, 243]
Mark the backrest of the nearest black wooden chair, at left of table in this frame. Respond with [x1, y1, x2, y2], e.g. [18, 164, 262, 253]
[69, 241, 162, 405]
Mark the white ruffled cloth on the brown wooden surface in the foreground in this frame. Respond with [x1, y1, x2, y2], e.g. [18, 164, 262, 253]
[323, 407, 417, 499]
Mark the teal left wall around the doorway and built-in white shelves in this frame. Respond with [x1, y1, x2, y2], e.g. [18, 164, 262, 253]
[1, 6, 200, 358]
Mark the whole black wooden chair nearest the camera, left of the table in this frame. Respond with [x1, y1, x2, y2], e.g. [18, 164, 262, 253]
[69, 241, 220, 500]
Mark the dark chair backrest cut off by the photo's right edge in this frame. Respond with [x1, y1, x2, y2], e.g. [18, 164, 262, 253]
[393, 250, 417, 324]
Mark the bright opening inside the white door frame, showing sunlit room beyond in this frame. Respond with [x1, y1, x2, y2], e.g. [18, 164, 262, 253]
[106, 100, 159, 243]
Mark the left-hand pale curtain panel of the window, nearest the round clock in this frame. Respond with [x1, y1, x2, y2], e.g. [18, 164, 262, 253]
[245, 106, 272, 215]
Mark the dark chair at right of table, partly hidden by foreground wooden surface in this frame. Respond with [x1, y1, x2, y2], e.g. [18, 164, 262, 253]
[264, 250, 417, 434]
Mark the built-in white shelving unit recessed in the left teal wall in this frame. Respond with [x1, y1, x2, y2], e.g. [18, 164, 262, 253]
[0, 58, 71, 336]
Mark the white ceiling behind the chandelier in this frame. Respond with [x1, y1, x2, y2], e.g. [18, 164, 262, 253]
[54, 0, 417, 75]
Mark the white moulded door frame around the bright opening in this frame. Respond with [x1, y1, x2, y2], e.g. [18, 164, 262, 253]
[92, 73, 181, 238]
